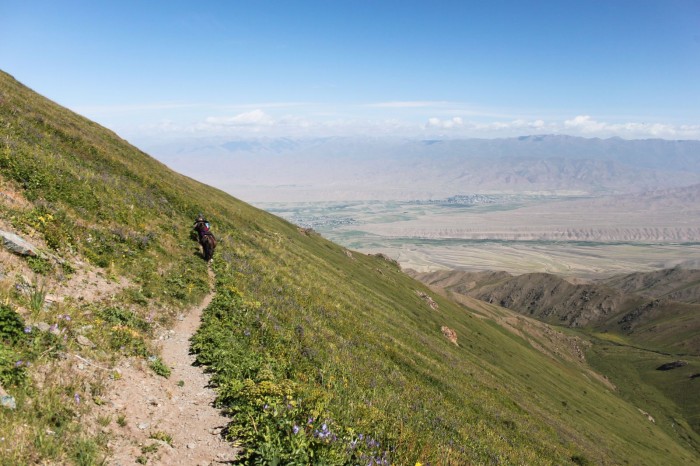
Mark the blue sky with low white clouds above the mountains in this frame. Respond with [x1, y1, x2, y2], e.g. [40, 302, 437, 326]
[0, 0, 700, 144]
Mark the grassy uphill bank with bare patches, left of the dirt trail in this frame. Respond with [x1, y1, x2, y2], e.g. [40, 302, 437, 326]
[0, 72, 209, 464]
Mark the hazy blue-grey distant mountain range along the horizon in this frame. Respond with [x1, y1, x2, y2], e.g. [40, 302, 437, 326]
[145, 135, 700, 201]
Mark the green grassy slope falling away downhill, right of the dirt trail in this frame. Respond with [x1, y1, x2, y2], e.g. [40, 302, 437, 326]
[193, 224, 696, 464]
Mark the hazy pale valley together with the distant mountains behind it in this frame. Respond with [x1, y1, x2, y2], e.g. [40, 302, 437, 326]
[152, 136, 700, 277]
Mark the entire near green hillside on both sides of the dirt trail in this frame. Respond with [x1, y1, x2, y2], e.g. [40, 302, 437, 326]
[0, 70, 700, 465]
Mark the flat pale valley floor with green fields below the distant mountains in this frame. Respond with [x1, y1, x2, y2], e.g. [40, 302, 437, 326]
[260, 199, 700, 278]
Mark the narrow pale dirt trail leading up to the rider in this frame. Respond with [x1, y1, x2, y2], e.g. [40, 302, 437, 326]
[103, 271, 236, 466]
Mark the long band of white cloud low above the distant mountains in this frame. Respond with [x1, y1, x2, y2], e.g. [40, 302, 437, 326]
[120, 105, 700, 144]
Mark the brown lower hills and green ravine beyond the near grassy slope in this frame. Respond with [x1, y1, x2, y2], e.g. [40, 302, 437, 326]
[412, 271, 700, 456]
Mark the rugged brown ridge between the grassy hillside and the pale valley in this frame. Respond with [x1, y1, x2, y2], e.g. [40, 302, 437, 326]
[410, 268, 700, 355]
